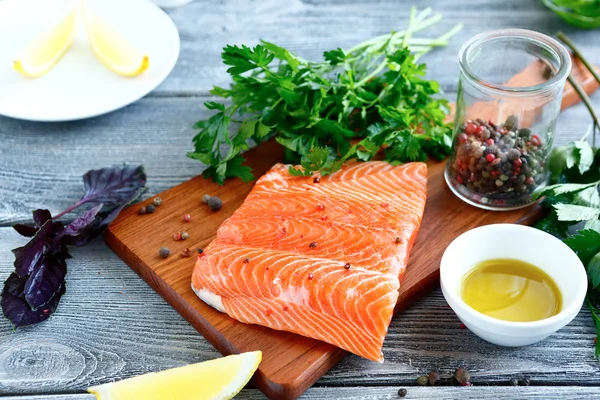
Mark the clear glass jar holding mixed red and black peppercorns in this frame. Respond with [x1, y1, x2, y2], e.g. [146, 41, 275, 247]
[445, 29, 571, 210]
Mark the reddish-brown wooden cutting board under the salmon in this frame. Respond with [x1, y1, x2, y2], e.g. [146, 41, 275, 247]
[104, 54, 597, 399]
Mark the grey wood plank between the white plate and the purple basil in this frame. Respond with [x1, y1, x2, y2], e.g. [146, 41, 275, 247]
[0, 93, 600, 226]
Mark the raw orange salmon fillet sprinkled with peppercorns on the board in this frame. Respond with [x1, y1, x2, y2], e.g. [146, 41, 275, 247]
[192, 161, 427, 362]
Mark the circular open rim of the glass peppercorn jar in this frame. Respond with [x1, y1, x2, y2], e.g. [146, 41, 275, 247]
[458, 28, 571, 95]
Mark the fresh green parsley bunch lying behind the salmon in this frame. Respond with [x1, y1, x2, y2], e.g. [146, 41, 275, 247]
[188, 7, 461, 184]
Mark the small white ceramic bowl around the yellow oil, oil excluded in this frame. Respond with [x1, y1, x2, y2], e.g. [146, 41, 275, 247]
[440, 224, 587, 346]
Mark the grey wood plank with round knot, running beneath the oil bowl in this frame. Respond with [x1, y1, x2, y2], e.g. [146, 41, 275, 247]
[0, 228, 600, 394]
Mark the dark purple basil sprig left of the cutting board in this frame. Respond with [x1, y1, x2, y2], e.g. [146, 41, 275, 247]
[1, 165, 146, 328]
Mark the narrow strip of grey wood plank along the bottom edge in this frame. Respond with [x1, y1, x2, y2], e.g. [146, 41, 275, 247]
[3, 386, 600, 400]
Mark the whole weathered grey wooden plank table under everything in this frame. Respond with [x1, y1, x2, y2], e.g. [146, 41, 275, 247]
[0, 0, 600, 400]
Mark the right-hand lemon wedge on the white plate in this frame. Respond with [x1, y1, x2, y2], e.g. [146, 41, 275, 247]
[82, 1, 150, 77]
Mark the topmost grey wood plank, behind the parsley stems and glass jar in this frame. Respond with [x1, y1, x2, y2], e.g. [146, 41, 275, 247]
[154, 0, 600, 96]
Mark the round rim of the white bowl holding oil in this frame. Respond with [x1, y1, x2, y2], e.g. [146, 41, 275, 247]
[440, 224, 588, 336]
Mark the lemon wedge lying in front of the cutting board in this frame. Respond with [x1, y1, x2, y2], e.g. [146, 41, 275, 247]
[88, 351, 262, 400]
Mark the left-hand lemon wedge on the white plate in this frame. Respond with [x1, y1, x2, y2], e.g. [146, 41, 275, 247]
[13, 7, 77, 78]
